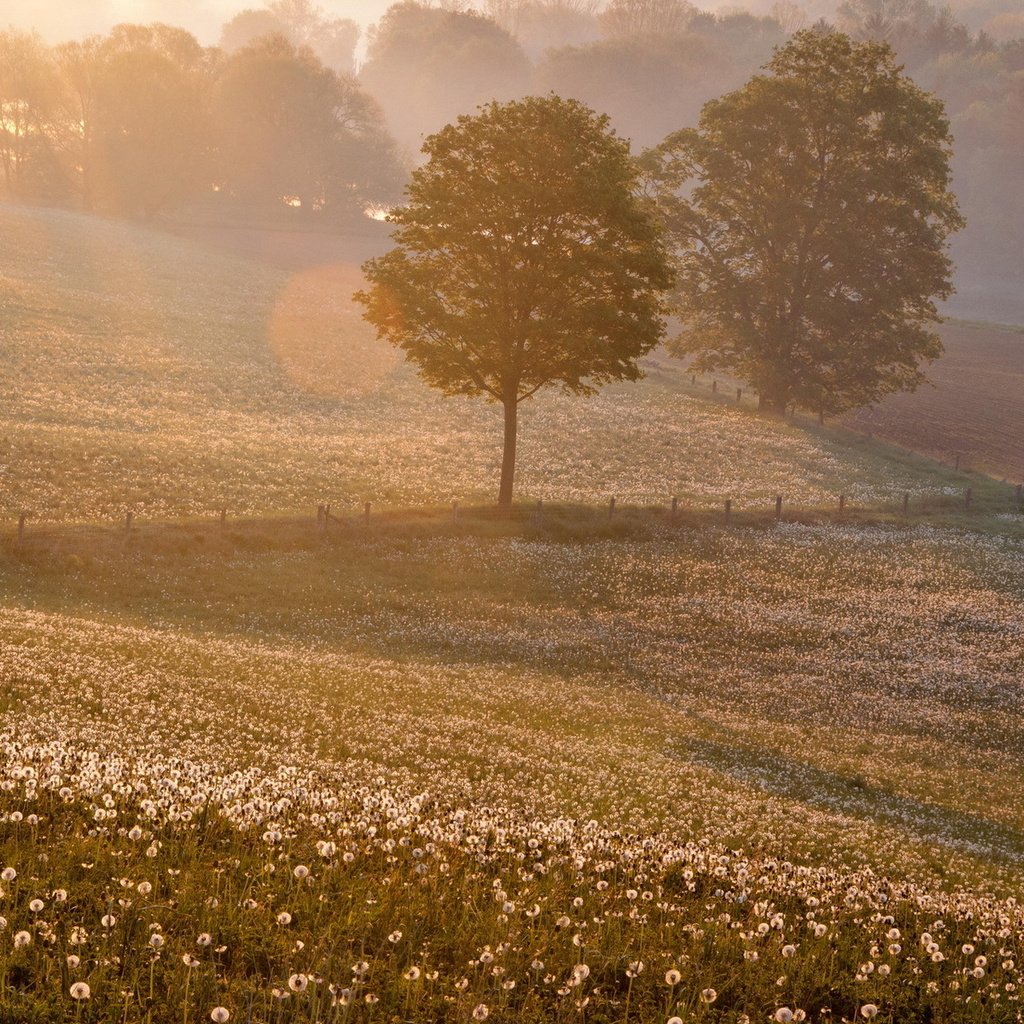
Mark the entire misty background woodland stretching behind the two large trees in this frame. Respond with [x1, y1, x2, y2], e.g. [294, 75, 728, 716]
[0, 0, 1024, 303]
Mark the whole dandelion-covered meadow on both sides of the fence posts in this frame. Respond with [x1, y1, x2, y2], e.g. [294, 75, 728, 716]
[0, 203, 1024, 1024]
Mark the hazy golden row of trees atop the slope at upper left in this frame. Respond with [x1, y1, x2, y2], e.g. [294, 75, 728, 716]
[0, 25, 406, 218]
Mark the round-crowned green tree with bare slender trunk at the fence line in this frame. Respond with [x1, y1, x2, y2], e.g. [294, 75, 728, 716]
[356, 96, 672, 509]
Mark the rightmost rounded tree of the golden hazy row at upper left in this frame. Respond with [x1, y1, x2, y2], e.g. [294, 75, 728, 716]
[214, 36, 403, 212]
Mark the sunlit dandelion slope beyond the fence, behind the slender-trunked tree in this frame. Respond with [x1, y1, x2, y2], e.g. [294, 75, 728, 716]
[0, 207, 999, 521]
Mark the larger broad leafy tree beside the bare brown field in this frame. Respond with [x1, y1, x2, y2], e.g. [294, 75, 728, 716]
[647, 32, 962, 414]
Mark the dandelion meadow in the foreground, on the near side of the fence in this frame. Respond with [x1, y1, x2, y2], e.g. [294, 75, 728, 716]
[0, 525, 1024, 1024]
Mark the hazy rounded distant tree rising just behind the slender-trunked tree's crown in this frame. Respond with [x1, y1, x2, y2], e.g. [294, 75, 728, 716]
[359, 0, 529, 150]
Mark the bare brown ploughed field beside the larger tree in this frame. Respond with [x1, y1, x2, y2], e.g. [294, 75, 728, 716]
[846, 321, 1024, 480]
